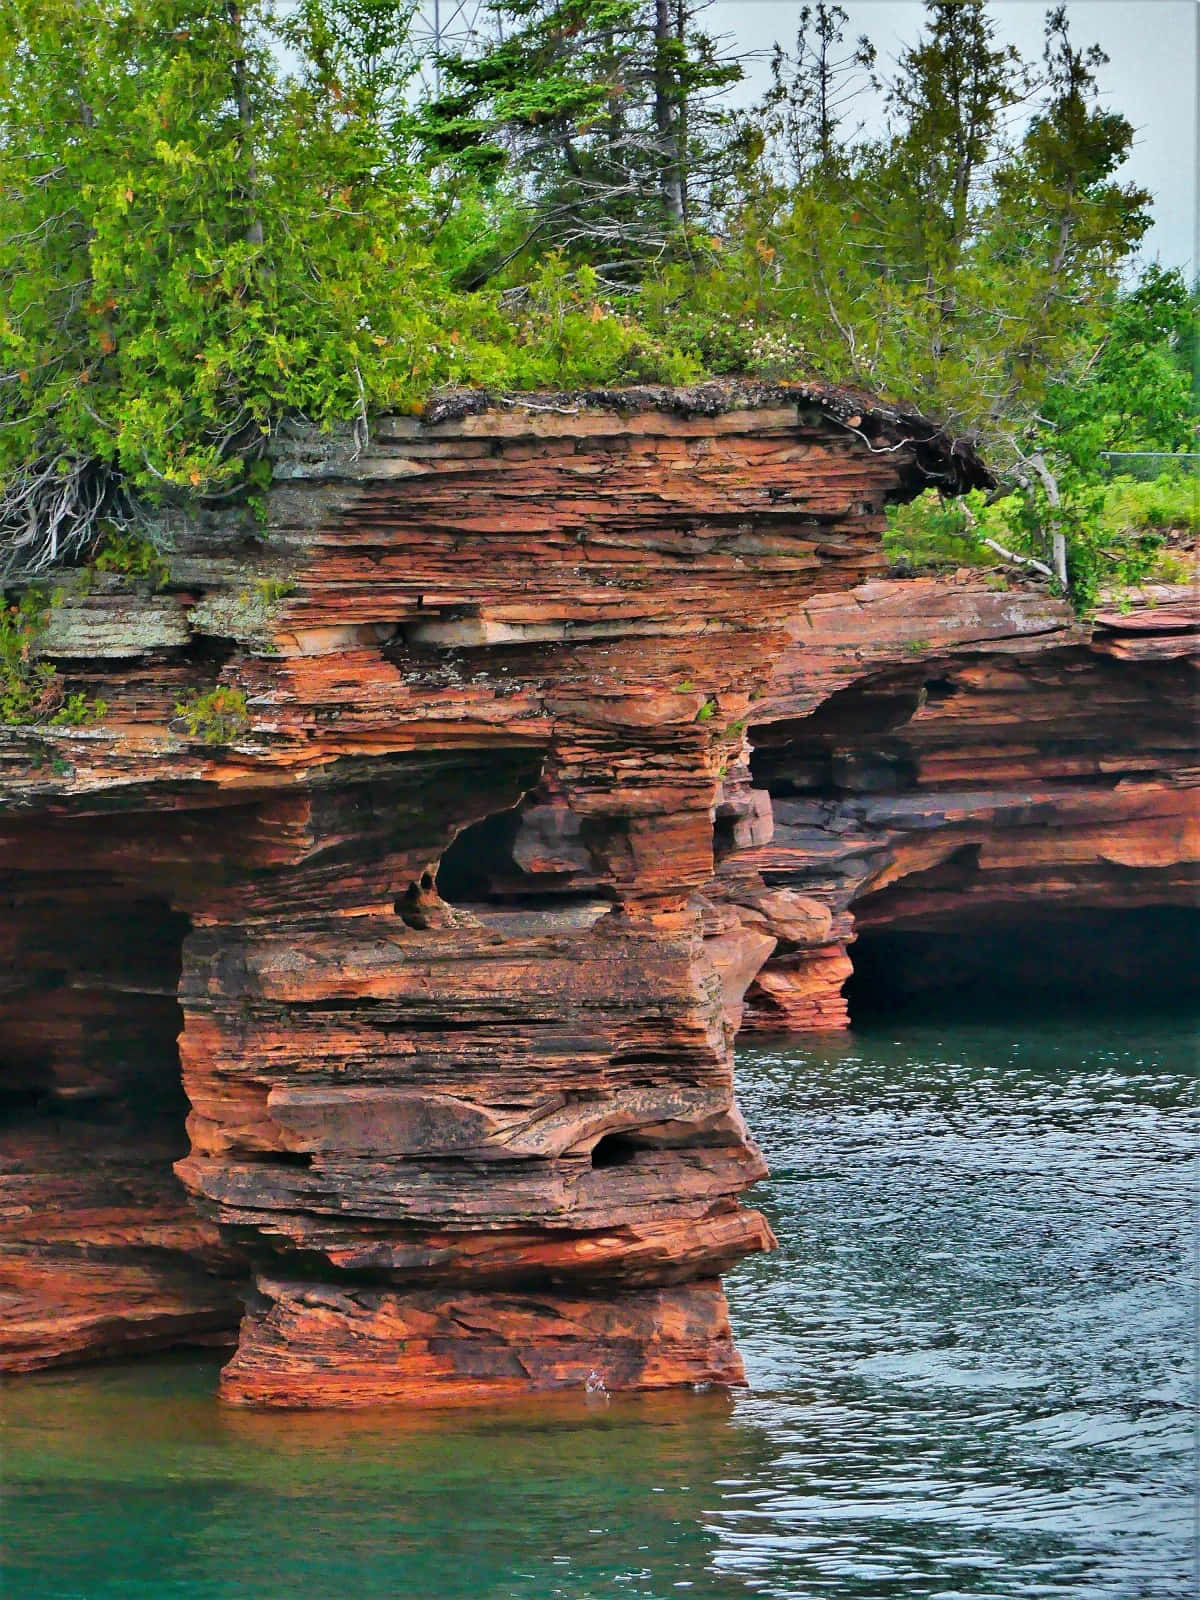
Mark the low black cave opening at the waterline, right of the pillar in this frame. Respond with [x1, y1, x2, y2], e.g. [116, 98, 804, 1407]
[845, 906, 1200, 1024]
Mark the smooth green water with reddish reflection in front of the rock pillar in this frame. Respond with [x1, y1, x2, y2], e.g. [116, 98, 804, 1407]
[3, 1360, 770, 1600]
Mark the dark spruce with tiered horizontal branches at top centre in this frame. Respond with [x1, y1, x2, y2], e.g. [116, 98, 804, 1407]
[426, 0, 741, 285]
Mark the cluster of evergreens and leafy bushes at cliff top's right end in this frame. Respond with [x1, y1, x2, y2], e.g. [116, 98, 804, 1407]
[646, 0, 1200, 606]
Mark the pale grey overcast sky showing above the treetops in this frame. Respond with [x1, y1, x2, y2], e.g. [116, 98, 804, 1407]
[704, 0, 1200, 274]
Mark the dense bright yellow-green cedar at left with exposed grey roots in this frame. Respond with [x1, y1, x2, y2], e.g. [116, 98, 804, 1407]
[0, 0, 441, 570]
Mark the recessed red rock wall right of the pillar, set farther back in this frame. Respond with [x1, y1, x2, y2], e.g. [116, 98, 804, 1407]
[736, 581, 1200, 1030]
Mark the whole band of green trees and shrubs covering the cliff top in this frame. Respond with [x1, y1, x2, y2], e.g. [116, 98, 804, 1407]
[0, 0, 1197, 601]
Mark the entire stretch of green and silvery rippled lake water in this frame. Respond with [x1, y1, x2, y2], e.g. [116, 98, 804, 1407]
[0, 1019, 1197, 1600]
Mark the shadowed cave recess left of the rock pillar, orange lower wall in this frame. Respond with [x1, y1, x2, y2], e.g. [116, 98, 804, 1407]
[0, 869, 242, 1371]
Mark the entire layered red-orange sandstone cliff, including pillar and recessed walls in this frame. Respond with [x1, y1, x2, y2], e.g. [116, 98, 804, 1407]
[0, 386, 1197, 1405]
